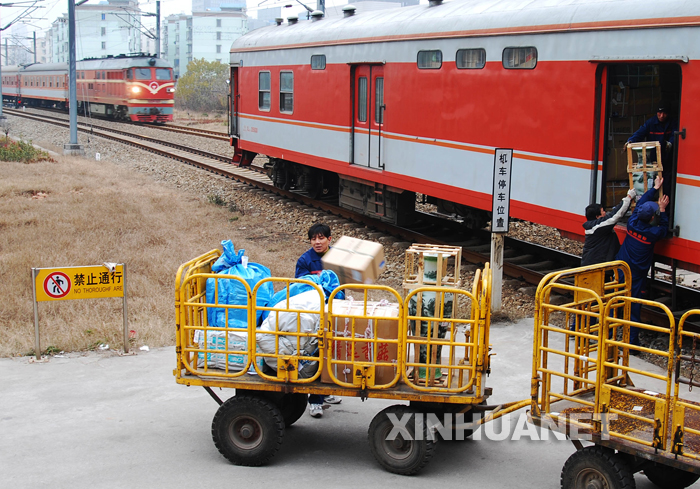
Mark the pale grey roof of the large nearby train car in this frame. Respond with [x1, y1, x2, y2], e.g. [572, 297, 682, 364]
[231, 0, 700, 52]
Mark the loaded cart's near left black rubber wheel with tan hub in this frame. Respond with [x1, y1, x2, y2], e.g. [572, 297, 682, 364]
[211, 394, 284, 466]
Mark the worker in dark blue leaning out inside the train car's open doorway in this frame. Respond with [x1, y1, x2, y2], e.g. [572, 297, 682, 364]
[623, 101, 678, 196]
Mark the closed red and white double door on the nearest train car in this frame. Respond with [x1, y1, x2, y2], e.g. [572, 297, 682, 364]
[352, 64, 386, 169]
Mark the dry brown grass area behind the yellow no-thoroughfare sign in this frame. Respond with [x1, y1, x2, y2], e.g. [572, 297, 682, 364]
[0, 157, 307, 356]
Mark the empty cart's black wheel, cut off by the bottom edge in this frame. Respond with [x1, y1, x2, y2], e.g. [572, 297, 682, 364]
[561, 446, 636, 489]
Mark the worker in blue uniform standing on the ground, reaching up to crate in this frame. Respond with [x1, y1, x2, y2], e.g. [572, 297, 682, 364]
[616, 175, 669, 345]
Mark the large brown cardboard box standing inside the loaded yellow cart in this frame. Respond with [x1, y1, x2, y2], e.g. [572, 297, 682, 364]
[321, 300, 399, 385]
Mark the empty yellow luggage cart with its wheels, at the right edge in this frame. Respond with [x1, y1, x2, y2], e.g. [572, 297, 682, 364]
[530, 262, 700, 489]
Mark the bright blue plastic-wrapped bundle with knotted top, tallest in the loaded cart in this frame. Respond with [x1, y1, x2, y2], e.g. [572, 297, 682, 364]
[207, 239, 275, 329]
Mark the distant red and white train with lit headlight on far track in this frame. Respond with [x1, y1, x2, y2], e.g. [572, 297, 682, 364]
[2, 55, 175, 123]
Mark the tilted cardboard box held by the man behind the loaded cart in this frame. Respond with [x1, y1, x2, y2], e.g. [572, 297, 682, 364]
[321, 236, 385, 284]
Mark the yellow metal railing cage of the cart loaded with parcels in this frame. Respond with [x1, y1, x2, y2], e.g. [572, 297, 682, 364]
[175, 250, 491, 396]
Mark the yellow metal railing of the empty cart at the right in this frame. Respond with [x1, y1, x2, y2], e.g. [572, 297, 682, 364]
[531, 262, 700, 458]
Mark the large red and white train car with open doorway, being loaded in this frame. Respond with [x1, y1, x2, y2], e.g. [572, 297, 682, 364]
[231, 0, 700, 270]
